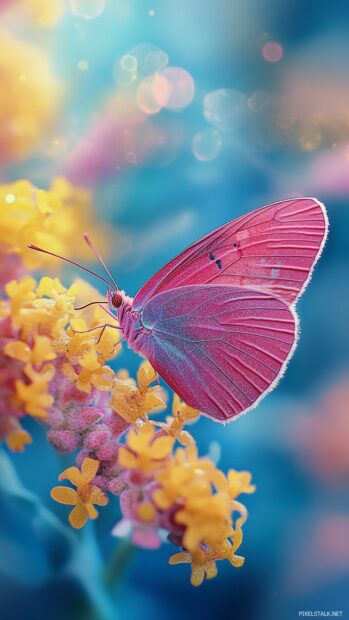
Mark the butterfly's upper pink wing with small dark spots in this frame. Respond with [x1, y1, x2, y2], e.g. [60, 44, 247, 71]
[133, 198, 328, 311]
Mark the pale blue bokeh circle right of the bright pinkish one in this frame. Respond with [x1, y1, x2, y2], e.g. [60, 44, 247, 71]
[204, 88, 248, 131]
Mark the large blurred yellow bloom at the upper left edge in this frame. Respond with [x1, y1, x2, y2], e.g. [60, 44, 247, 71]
[0, 30, 61, 164]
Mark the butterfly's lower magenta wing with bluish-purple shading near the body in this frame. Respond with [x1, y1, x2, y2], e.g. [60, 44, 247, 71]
[141, 285, 297, 422]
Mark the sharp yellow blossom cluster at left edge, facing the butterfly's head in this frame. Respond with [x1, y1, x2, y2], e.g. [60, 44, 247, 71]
[0, 276, 120, 445]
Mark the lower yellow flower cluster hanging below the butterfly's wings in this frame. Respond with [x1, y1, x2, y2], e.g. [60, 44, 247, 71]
[118, 396, 255, 585]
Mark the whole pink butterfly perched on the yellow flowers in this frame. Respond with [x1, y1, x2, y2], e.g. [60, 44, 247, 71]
[32, 198, 328, 423]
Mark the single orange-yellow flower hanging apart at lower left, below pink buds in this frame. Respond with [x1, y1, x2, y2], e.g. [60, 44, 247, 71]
[51, 458, 108, 529]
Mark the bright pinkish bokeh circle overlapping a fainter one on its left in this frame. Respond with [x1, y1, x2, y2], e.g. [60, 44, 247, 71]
[153, 67, 195, 110]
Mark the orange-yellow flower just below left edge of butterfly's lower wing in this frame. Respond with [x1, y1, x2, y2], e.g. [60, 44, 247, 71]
[110, 361, 166, 424]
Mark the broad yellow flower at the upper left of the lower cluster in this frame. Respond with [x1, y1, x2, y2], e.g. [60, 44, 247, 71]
[118, 422, 174, 474]
